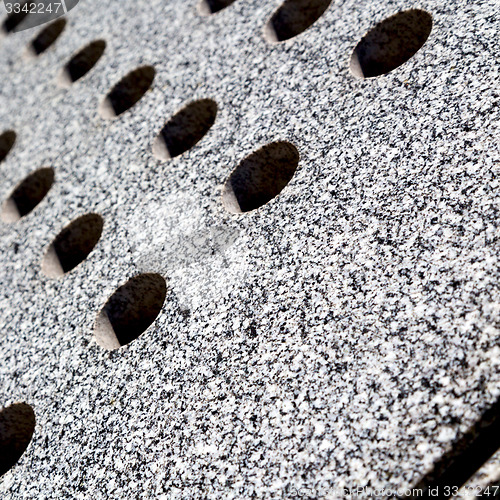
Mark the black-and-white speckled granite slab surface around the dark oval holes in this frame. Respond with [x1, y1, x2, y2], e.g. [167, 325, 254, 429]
[0, 0, 500, 499]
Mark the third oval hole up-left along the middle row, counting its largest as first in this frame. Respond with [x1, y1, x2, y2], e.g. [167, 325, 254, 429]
[100, 66, 156, 118]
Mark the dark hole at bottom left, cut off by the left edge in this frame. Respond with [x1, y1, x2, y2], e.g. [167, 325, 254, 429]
[0, 403, 35, 476]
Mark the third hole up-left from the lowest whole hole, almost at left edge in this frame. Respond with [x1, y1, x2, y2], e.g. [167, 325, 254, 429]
[1, 168, 54, 222]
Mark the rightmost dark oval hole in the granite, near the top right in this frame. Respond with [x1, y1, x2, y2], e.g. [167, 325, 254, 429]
[350, 9, 432, 78]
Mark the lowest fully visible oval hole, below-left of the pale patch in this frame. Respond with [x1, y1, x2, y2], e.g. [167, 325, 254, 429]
[95, 274, 167, 351]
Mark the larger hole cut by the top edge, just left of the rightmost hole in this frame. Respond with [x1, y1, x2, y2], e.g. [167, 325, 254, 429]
[264, 0, 332, 42]
